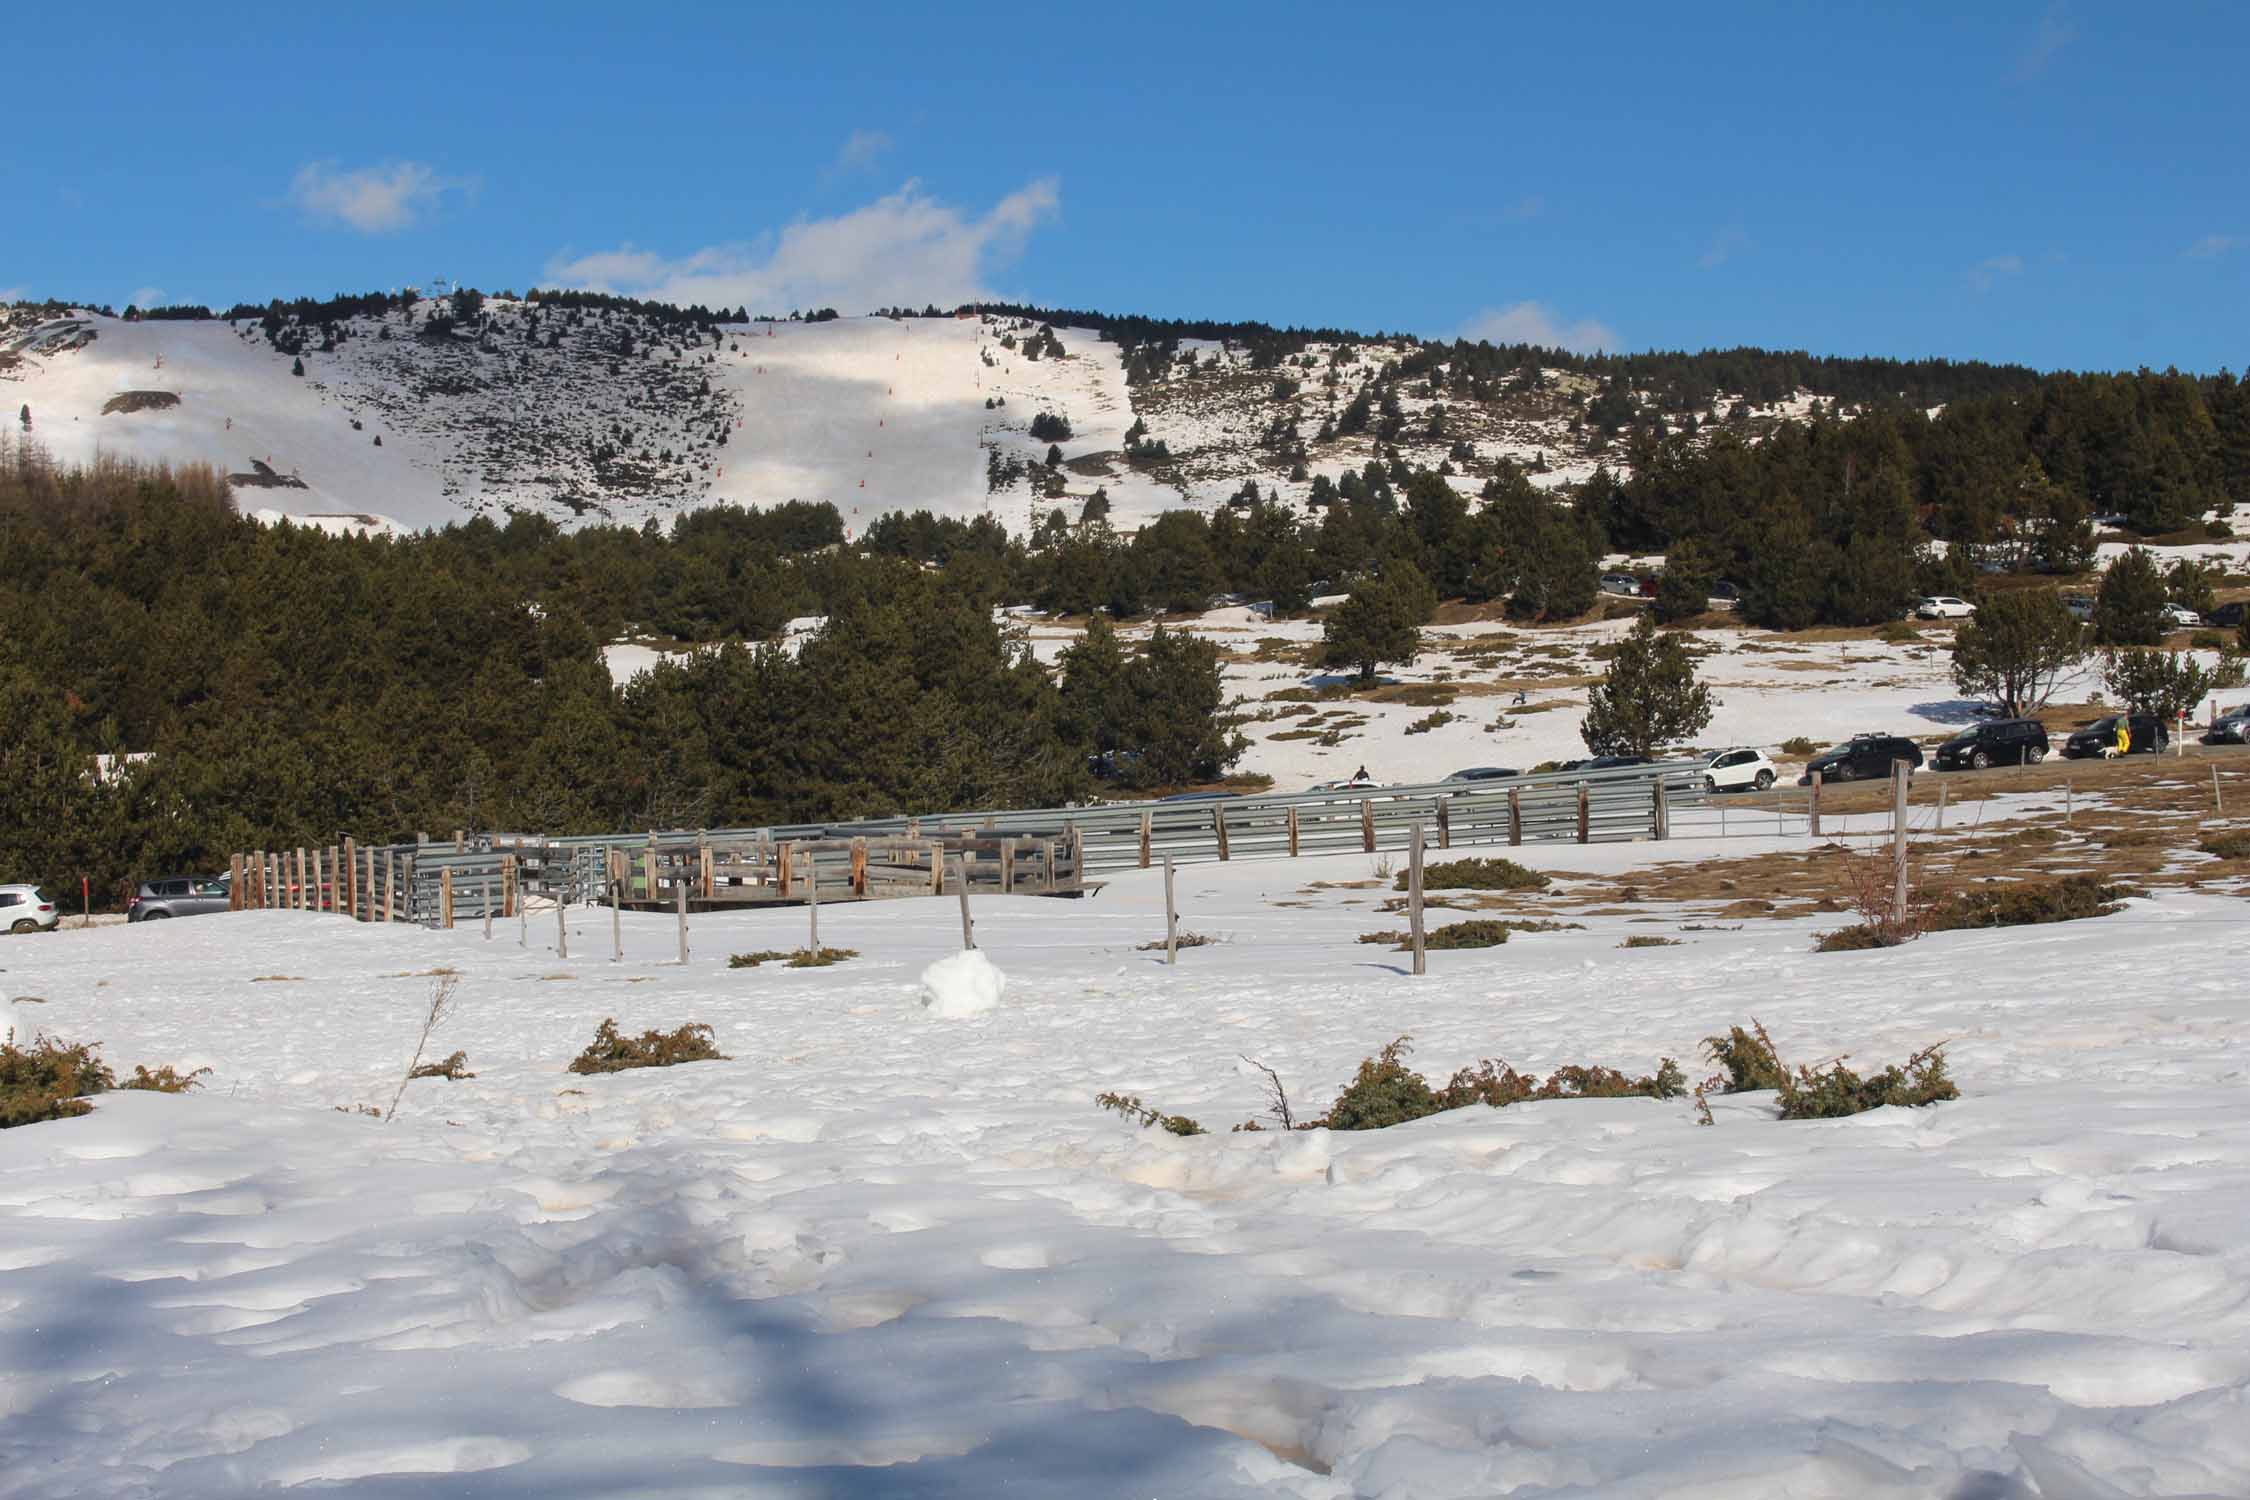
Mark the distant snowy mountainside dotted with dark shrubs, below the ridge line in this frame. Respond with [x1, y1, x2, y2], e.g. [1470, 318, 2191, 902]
[0, 297, 1827, 531]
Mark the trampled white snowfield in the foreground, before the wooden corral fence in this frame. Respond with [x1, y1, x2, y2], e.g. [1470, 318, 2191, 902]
[0, 841, 2250, 1500]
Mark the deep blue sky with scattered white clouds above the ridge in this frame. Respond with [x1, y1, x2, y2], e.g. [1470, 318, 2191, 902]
[0, 0, 2250, 371]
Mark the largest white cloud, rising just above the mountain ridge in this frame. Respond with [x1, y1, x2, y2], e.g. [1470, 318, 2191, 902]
[547, 178, 1062, 313]
